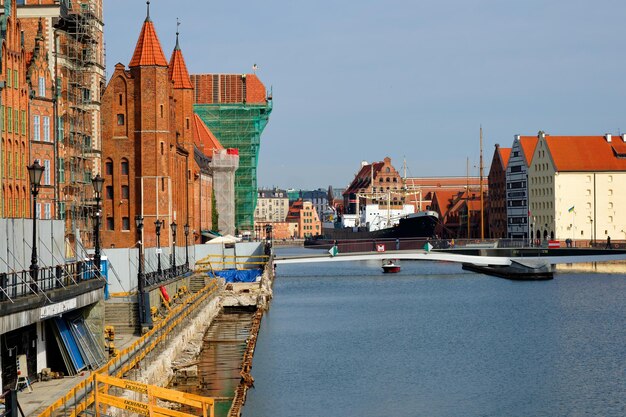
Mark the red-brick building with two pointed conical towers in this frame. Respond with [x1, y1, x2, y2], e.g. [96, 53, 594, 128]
[102, 9, 197, 247]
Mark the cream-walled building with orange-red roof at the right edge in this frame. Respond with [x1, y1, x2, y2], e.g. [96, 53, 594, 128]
[528, 132, 626, 241]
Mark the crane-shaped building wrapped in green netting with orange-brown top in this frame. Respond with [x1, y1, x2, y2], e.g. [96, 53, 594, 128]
[191, 74, 272, 232]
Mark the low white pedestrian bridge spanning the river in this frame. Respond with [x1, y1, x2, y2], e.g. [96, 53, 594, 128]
[274, 248, 626, 266]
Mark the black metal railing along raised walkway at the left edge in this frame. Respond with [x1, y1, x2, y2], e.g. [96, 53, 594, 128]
[0, 260, 99, 302]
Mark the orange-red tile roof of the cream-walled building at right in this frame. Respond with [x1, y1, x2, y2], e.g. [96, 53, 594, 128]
[546, 135, 626, 171]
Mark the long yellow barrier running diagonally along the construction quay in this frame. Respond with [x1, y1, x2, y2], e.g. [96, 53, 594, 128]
[39, 281, 217, 417]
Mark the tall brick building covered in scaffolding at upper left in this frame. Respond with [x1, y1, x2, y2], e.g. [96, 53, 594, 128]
[18, 0, 105, 256]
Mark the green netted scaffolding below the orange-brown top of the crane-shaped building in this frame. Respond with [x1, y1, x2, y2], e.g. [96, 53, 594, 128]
[194, 99, 272, 233]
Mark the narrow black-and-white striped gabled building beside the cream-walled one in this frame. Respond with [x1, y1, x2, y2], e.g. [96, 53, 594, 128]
[506, 135, 537, 239]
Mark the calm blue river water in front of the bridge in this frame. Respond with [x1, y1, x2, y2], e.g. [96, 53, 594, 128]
[244, 249, 626, 417]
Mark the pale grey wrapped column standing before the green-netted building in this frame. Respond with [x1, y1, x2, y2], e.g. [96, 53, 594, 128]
[211, 149, 239, 235]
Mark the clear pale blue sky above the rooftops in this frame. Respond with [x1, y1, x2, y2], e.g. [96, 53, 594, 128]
[104, 0, 626, 189]
